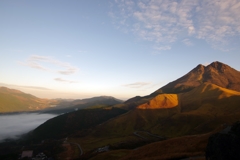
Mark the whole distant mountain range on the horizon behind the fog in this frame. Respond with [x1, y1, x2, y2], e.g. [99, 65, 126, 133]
[0, 87, 123, 114]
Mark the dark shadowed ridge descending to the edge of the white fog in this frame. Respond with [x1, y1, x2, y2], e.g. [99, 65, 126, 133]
[27, 107, 126, 140]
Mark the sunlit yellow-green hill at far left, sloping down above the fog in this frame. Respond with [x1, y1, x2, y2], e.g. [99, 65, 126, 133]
[0, 87, 57, 113]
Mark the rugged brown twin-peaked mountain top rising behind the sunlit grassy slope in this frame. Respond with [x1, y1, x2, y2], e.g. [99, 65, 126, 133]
[151, 61, 240, 95]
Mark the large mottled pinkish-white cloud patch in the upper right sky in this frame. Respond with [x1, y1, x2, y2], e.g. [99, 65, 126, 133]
[109, 0, 240, 50]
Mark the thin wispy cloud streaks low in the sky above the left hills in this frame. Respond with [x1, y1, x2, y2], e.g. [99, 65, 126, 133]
[19, 55, 79, 75]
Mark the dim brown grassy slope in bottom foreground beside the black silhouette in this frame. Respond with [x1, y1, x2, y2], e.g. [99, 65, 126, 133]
[121, 129, 223, 160]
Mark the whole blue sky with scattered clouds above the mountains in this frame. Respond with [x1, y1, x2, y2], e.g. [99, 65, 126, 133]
[0, 0, 240, 100]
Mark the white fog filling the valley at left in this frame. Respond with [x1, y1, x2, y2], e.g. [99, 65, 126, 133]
[0, 113, 57, 141]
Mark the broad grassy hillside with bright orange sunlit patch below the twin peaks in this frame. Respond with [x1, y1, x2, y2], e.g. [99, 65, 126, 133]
[65, 83, 240, 154]
